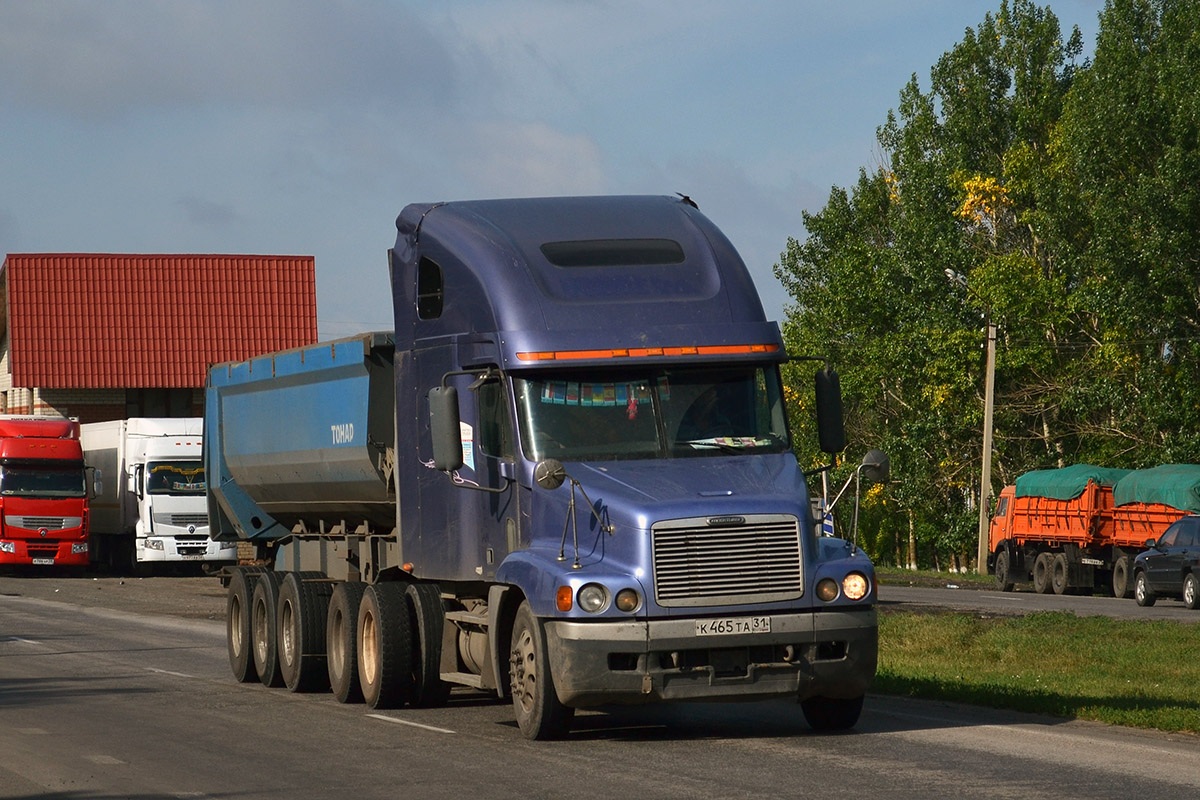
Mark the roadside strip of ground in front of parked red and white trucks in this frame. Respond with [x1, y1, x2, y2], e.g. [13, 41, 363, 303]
[0, 572, 226, 620]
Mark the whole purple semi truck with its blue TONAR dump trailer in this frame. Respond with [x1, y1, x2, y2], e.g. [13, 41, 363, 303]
[204, 197, 877, 739]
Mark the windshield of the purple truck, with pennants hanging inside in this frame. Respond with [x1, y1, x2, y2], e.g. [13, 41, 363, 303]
[514, 365, 790, 461]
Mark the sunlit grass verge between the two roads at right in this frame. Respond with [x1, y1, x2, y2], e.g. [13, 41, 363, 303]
[872, 612, 1200, 733]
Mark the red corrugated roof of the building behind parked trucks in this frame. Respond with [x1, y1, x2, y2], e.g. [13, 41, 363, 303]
[0, 253, 317, 389]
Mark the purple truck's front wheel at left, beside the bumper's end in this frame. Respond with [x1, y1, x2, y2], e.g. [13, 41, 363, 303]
[509, 601, 575, 739]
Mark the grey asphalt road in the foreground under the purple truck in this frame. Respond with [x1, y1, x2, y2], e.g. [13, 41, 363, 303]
[0, 590, 1200, 800]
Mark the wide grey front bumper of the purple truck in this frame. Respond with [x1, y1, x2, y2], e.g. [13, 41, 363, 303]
[545, 607, 878, 708]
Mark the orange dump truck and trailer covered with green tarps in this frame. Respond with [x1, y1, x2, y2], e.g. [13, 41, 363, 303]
[988, 464, 1200, 597]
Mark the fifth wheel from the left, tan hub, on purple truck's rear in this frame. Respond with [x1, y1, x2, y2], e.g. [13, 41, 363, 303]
[355, 582, 413, 709]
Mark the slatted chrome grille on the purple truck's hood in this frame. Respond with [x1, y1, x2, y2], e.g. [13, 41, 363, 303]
[650, 515, 804, 607]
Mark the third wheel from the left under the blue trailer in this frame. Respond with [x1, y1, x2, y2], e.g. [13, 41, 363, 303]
[276, 572, 332, 692]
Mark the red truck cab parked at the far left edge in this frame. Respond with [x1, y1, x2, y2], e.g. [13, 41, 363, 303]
[0, 415, 89, 566]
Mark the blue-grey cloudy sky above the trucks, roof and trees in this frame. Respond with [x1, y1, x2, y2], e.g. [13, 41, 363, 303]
[0, 0, 1104, 341]
